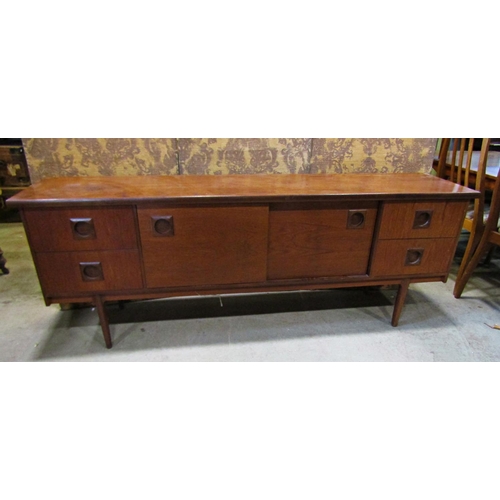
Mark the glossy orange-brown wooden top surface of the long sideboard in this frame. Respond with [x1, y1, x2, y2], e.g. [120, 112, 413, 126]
[7, 174, 479, 207]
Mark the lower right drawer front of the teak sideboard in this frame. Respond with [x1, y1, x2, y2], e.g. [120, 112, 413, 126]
[370, 238, 457, 277]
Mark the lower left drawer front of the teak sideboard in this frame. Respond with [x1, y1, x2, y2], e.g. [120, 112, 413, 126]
[35, 250, 143, 296]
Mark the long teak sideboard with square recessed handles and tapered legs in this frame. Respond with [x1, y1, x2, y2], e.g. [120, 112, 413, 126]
[8, 174, 478, 348]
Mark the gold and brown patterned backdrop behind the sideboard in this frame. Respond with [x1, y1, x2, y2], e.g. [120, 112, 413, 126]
[23, 139, 436, 182]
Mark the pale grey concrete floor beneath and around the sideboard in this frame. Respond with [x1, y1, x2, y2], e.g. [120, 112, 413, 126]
[0, 218, 500, 361]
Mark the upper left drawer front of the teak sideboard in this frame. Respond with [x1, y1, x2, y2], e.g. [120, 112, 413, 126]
[24, 207, 137, 252]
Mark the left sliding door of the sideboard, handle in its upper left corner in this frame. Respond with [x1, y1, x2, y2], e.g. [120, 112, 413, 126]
[138, 206, 268, 288]
